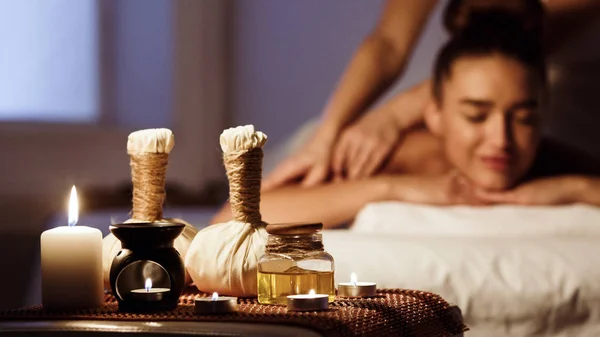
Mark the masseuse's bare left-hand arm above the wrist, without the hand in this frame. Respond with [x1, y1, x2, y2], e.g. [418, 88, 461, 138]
[323, 0, 437, 132]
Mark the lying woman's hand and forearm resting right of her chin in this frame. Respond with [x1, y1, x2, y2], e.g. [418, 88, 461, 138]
[476, 176, 581, 205]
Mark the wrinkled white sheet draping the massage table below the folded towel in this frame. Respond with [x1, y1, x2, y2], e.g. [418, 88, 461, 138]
[324, 231, 600, 336]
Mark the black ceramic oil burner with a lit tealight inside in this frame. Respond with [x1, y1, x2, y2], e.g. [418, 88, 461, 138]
[110, 222, 185, 312]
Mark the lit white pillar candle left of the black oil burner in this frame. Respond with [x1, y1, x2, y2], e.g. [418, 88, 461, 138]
[40, 186, 104, 309]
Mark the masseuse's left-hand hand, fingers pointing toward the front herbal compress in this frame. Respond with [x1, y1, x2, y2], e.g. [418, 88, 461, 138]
[262, 128, 335, 191]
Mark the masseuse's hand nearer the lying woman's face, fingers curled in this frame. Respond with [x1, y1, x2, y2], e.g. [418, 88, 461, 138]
[331, 108, 402, 179]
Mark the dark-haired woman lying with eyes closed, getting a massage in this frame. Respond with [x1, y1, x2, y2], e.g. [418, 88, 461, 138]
[213, 11, 600, 228]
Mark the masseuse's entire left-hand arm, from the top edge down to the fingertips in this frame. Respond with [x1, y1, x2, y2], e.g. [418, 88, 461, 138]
[265, 0, 437, 189]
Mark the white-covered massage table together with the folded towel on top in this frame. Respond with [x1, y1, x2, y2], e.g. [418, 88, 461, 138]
[336, 202, 600, 336]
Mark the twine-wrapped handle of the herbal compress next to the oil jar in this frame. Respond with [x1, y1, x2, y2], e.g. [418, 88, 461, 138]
[220, 125, 267, 225]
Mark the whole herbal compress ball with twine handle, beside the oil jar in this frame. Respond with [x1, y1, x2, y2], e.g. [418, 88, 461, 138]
[185, 125, 267, 297]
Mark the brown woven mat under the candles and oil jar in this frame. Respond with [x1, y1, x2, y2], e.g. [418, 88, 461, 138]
[0, 289, 467, 336]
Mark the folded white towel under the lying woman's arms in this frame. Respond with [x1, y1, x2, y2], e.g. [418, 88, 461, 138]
[351, 201, 600, 237]
